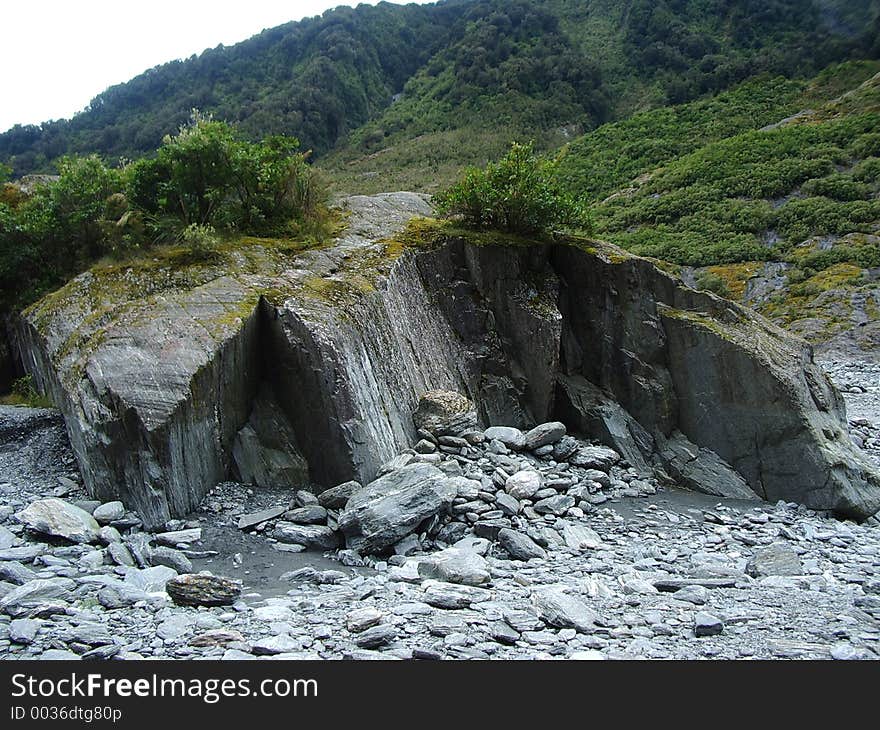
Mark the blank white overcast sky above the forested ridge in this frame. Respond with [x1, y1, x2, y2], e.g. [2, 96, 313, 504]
[0, 0, 436, 132]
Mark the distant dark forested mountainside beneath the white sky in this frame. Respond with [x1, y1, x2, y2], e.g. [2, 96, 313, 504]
[0, 0, 880, 179]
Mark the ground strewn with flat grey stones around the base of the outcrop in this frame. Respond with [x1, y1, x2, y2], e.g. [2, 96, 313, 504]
[0, 363, 880, 659]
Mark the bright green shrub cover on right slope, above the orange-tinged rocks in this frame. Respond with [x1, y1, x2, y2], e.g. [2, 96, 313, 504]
[561, 64, 880, 266]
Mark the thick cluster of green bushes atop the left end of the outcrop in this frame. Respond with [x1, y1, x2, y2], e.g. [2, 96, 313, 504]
[0, 113, 328, 308]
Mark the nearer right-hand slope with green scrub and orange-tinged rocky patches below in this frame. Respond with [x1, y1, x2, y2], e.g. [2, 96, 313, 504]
[560, 62, 880, 355]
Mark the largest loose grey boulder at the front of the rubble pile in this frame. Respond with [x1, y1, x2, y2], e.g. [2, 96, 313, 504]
[339, 464, 458, 554]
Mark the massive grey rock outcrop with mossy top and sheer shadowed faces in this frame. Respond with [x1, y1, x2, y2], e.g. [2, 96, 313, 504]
[12, 193, 880, 525]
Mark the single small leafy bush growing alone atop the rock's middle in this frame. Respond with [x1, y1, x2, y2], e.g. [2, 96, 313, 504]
[436, 143, 587, 234]
